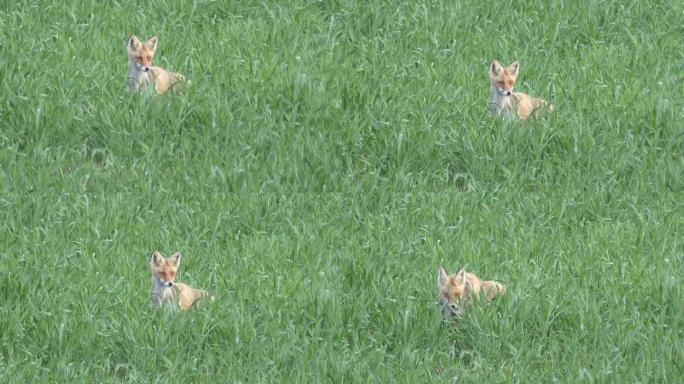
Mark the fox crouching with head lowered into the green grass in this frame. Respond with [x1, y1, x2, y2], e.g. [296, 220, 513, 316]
[437, 267, 506, 319]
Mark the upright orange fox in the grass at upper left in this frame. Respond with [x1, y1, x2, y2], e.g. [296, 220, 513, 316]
[127, 35, 192, 95]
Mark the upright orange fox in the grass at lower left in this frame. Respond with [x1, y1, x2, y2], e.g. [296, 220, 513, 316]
[150, 251, 214, 311]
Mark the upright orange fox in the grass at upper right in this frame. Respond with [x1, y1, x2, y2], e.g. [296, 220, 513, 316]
[489, 60, 554, 120]
